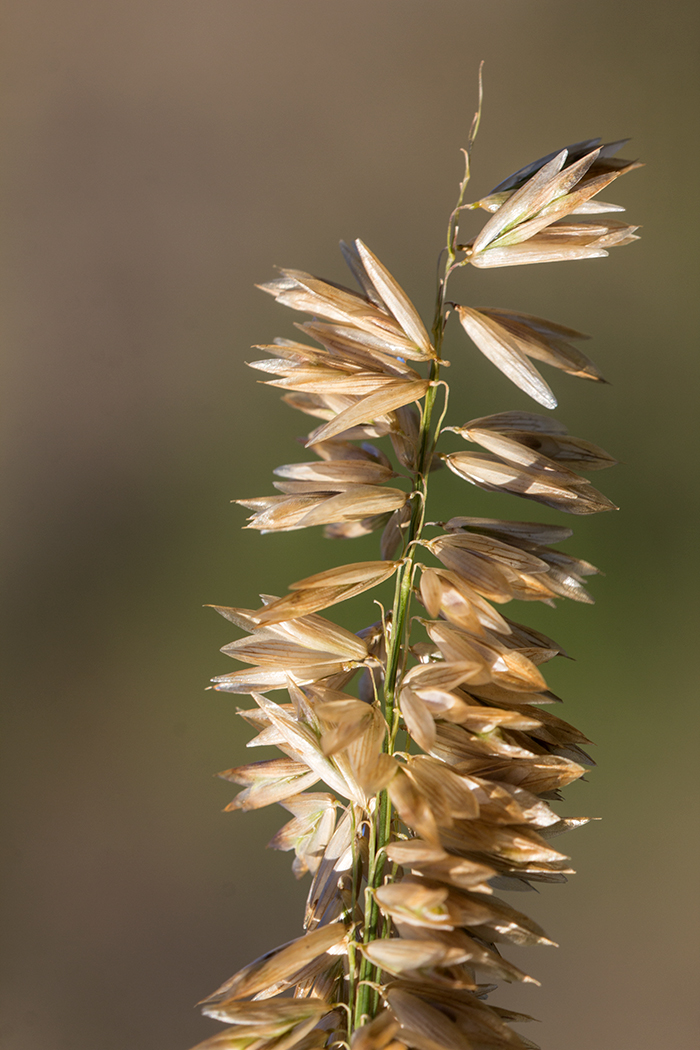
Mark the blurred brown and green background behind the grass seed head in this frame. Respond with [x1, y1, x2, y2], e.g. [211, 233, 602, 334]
[0, 6, 699, 1050]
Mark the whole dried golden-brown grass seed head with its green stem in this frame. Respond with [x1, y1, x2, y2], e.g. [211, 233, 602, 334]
[198, 104, 637, 1050]
